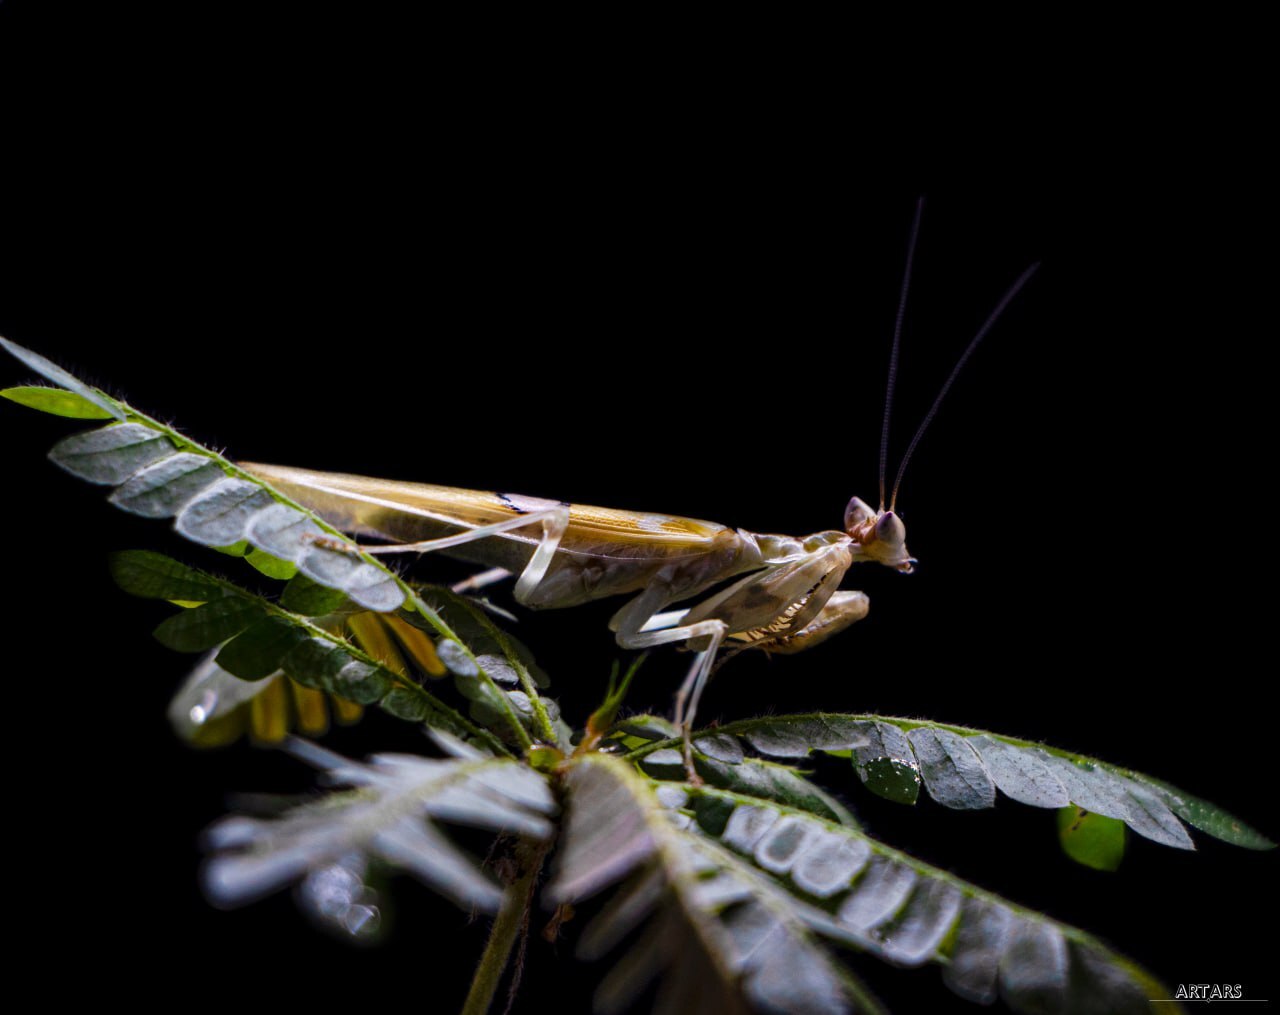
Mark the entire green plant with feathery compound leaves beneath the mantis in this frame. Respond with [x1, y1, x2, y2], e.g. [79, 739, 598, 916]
[0, 340, 1272, 1015]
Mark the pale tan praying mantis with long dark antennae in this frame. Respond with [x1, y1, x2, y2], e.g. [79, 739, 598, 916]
[239, 207, 1037, 777]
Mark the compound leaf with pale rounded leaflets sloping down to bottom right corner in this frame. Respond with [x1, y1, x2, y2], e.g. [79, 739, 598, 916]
[686, 787, 1169, 1015]
